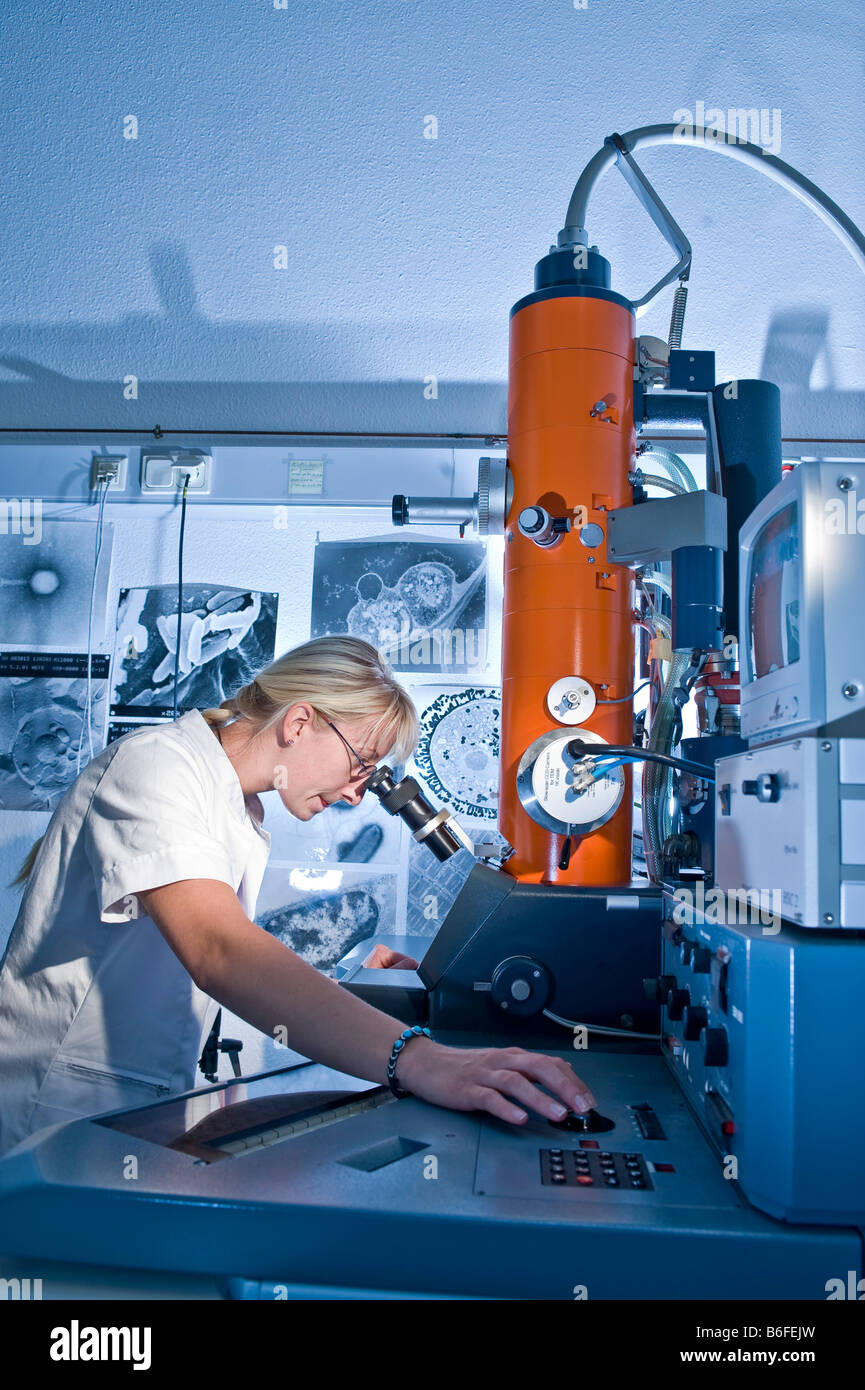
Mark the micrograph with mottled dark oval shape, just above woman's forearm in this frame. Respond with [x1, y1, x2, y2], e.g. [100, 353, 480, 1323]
[254, 863, 402, 976]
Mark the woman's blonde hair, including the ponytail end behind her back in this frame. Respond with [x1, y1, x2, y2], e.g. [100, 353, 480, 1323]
[10, 634, 420, 888]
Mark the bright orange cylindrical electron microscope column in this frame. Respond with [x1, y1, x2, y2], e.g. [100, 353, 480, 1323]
[499, 293, 636, 885]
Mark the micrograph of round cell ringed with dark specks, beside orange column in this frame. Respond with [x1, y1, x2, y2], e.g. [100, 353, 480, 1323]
[410, 687, 502, 820]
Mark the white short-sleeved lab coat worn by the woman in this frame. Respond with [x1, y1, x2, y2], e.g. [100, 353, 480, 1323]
[0, 710, 270, 1154]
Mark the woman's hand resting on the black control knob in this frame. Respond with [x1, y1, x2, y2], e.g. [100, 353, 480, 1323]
[396, 1037, 598, 1125]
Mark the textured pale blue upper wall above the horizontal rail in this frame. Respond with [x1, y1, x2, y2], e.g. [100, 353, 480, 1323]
[0, 0, 865, 436]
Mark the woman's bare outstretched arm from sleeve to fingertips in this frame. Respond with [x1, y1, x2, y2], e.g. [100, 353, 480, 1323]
[136, 878, 595, 1123]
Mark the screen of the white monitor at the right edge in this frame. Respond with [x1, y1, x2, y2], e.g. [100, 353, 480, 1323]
[748, 502, 801, 678]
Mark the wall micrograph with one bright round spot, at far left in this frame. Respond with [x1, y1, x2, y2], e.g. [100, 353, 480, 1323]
[0, 522, 114, 652]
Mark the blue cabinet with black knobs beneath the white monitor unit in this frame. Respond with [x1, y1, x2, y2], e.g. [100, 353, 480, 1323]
[656, 881, 865, 1223]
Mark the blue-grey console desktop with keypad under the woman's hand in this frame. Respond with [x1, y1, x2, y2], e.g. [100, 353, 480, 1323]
[0, 1034, 862, 1300]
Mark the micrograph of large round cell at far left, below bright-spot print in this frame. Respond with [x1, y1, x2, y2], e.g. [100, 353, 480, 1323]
[0, 652, 108, 810]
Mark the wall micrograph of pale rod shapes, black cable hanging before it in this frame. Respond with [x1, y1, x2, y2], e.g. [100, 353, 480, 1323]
[111, 584, 278, 717]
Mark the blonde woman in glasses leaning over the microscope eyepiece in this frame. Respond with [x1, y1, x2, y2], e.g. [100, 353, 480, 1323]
[0, 637, 595, 1154]
